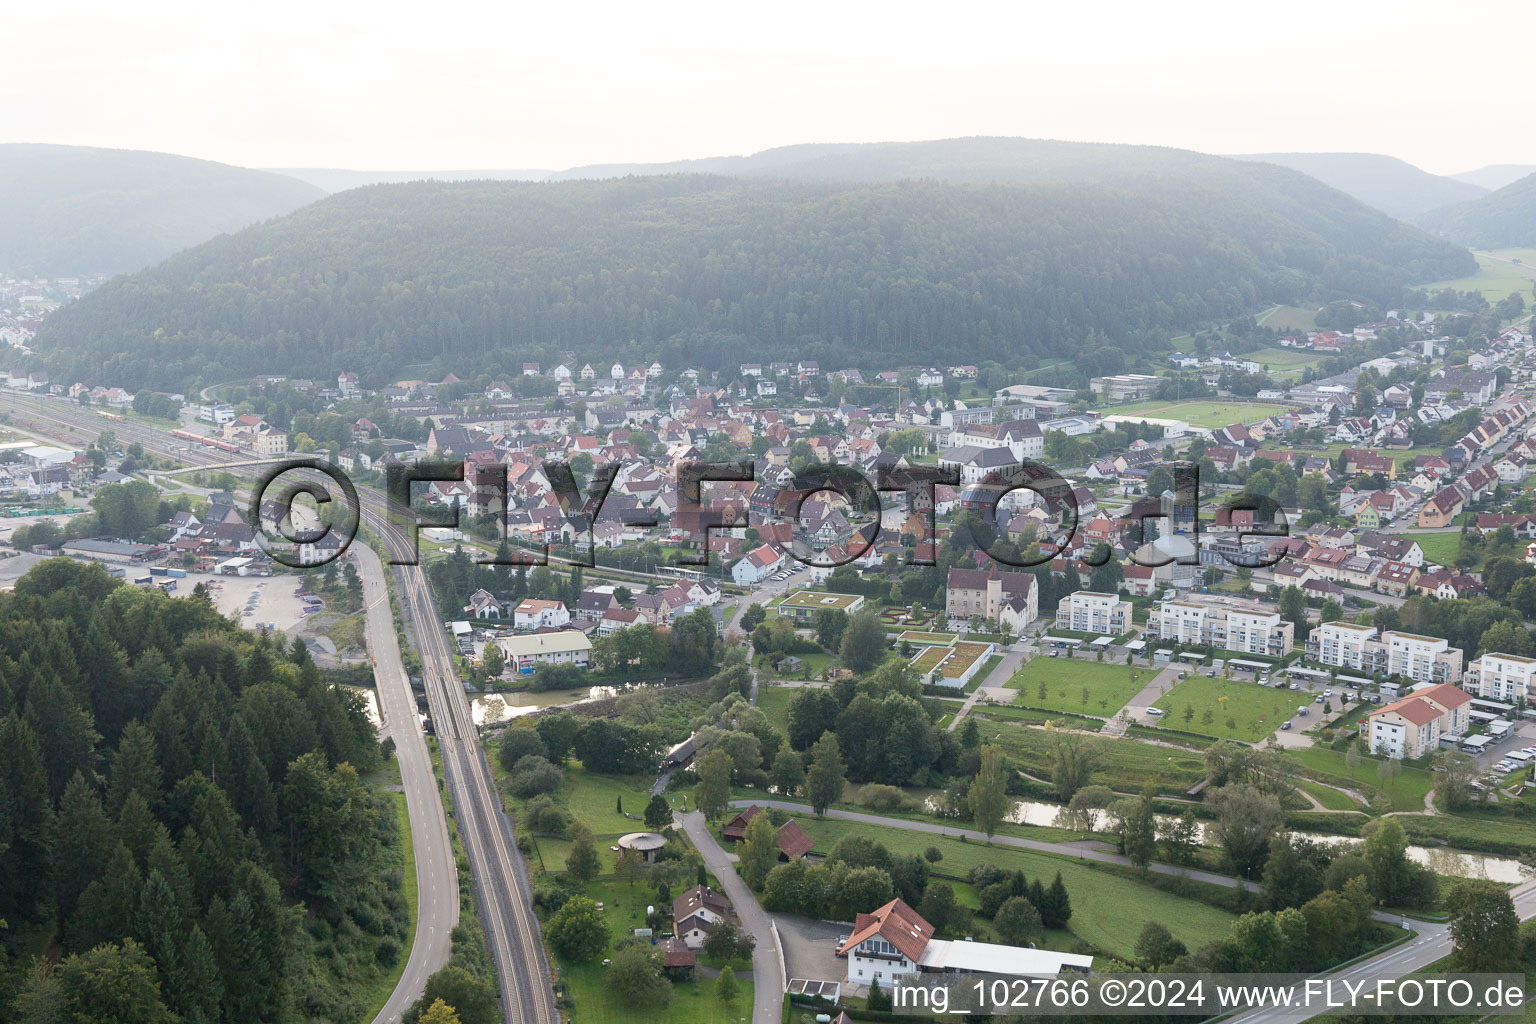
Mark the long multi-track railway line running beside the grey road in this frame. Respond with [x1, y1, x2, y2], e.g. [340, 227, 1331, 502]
[0, 393, 561, 1024]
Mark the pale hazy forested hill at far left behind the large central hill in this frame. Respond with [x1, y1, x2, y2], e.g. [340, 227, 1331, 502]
[0, 143, 324, 278]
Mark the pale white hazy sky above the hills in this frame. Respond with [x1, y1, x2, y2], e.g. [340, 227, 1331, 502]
[0, 0, 1536, 173]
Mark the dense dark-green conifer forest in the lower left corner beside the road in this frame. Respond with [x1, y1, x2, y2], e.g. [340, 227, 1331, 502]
[0, 559, 409, 1024]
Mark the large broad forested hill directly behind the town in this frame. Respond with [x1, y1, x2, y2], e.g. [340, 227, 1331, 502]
[34, 164, 1475, 390]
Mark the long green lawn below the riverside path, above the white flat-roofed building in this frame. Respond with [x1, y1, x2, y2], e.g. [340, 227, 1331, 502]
[796, 815, 1233, 960]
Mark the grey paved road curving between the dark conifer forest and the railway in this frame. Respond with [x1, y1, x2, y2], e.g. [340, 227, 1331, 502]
[353, 545, 459, 1024]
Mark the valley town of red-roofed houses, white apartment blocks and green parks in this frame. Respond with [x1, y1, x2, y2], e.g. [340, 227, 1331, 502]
[0, 282, 1536, 1019]
